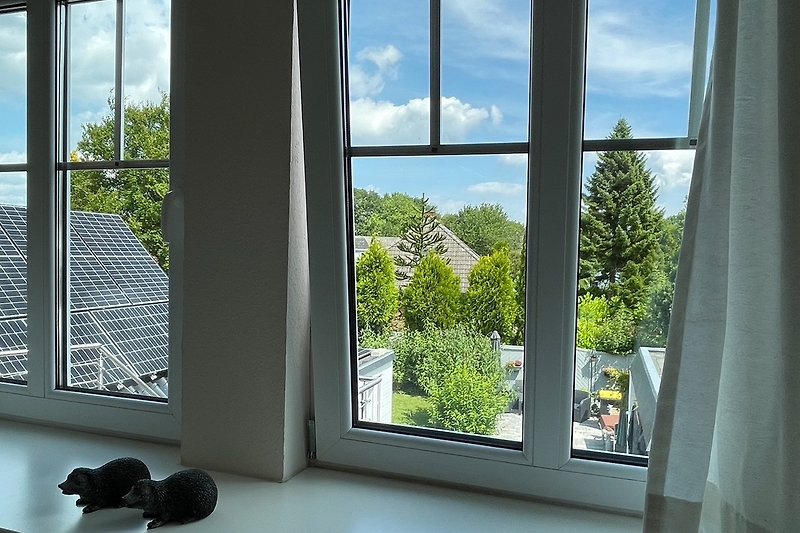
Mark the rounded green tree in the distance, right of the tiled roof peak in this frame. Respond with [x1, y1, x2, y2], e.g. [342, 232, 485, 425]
[442, 204, 525, 255]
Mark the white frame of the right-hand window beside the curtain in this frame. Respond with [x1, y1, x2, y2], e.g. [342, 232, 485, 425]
[298, 0, 708, 513]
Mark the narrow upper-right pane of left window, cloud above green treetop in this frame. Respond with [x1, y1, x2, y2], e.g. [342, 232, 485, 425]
[123, 0, 170, 159]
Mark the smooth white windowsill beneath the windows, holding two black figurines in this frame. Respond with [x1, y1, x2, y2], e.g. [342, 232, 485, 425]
[0, 420, 641, 533]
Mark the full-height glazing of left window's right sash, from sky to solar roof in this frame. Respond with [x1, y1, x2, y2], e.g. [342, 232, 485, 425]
[59, 0, 169, 400]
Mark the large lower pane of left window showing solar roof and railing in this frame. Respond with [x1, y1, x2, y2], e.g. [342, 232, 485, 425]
[63, 169, 169, 398]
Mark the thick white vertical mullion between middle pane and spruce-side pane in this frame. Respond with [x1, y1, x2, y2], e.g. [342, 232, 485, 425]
[523, 0, 586, 468]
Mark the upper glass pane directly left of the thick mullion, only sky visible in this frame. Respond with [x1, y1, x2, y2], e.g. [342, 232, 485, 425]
[441, 0, 530, 143]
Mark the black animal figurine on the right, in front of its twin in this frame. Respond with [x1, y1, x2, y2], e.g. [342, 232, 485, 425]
[122, 469, 217, 529]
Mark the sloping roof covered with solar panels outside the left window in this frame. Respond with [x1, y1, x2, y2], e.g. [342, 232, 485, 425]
[0, 205, 169, 397]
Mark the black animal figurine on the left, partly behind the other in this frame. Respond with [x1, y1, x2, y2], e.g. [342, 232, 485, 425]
[58, 457, 150, 513]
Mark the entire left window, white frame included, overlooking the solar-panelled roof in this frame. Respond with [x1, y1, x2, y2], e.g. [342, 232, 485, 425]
[0, 0, 180, 439]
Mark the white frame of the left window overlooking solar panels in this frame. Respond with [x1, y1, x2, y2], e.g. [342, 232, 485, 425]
[0, 0, 183, 442]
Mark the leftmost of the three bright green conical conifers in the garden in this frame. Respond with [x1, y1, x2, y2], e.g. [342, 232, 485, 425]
[356, 239, 399, 333]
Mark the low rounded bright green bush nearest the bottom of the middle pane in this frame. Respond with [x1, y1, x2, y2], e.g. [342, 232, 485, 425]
[430, 364, 511, 435]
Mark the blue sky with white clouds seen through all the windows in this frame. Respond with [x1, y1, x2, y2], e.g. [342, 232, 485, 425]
[0, 0, 708, 221]
